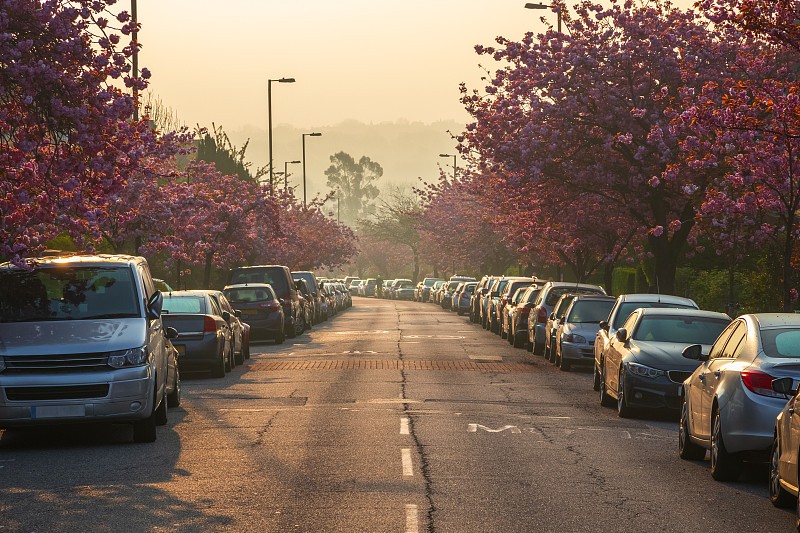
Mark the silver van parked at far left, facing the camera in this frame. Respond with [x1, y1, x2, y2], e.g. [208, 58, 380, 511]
[0, 255, 180, 442]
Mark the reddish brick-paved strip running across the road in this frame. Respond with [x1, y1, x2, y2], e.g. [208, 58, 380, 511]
[250, 359, 535, 372]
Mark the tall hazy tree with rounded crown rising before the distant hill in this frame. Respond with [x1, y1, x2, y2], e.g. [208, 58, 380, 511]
[325, 152, 383, 223]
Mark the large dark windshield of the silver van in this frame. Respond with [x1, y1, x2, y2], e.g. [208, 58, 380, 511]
[0, 266, 141, 322]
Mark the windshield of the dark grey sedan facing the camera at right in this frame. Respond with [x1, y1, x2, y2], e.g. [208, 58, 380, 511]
[632, 315, 730, 344]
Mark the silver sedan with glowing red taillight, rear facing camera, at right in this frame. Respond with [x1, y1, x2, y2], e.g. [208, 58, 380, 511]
[679, 313, 800, 481]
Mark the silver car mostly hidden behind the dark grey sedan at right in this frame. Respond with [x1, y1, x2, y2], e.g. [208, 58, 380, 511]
[592, 294, 699, 391]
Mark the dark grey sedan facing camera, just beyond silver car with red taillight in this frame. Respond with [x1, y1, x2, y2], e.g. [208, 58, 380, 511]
[600, 308, 731, 417]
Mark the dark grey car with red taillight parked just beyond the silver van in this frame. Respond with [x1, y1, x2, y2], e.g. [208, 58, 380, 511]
[163, 290, 235, 378]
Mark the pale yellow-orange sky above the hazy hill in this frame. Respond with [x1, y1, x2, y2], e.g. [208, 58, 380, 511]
[136, 0, 693, 197]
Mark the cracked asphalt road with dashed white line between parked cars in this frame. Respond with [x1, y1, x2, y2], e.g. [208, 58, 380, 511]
[0, 298, 794, 533]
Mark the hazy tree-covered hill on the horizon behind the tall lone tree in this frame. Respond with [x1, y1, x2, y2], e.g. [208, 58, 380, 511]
[222, 120, 464, 203]
